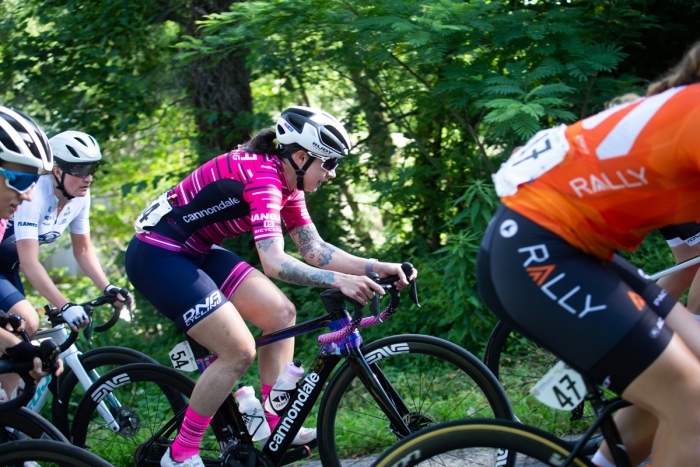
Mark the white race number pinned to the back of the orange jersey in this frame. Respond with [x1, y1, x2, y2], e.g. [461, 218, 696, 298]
[493, 125, 570, 197]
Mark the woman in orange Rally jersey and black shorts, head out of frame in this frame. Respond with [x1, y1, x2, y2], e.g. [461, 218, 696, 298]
[477, 43, 700, 466]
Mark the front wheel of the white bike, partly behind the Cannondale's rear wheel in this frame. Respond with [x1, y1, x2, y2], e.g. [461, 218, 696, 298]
[51, 346, 158, 436]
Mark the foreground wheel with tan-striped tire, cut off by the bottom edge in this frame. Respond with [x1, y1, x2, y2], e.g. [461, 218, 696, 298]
[372, 419, 593, 467]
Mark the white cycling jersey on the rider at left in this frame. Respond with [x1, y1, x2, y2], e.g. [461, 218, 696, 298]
[0, 174, 90, 266]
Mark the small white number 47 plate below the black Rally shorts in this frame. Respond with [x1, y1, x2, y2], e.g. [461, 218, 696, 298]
[530, 360, 586, 411]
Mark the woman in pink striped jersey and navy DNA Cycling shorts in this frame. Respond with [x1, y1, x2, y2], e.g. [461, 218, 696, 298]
[126, 107, 416, 467]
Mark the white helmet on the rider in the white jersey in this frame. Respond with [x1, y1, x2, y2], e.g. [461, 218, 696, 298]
[49, 130, 102, 199]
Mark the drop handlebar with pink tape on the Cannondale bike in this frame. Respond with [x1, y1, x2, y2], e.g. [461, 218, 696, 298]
[318, 262, 420, 345]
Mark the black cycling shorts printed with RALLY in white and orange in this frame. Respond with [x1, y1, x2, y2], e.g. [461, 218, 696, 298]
[477, 205, 676, 394]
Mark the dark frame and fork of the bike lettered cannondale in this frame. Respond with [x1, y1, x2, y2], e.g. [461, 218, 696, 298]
[141, 290, 418, 465]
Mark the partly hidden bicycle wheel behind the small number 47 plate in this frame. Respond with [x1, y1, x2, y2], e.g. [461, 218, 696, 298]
[484, 321, 602, 454]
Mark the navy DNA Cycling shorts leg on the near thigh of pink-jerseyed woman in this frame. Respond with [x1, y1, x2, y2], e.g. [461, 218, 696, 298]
[125, 238, 227, 332]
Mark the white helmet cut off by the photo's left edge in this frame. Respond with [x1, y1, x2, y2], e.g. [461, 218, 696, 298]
[0, 106, 53, 170]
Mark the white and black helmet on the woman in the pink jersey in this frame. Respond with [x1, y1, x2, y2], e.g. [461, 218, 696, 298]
[275, 106, 352, 190]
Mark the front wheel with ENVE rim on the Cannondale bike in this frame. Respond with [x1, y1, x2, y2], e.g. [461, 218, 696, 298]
[318, 334, 512, 467]
